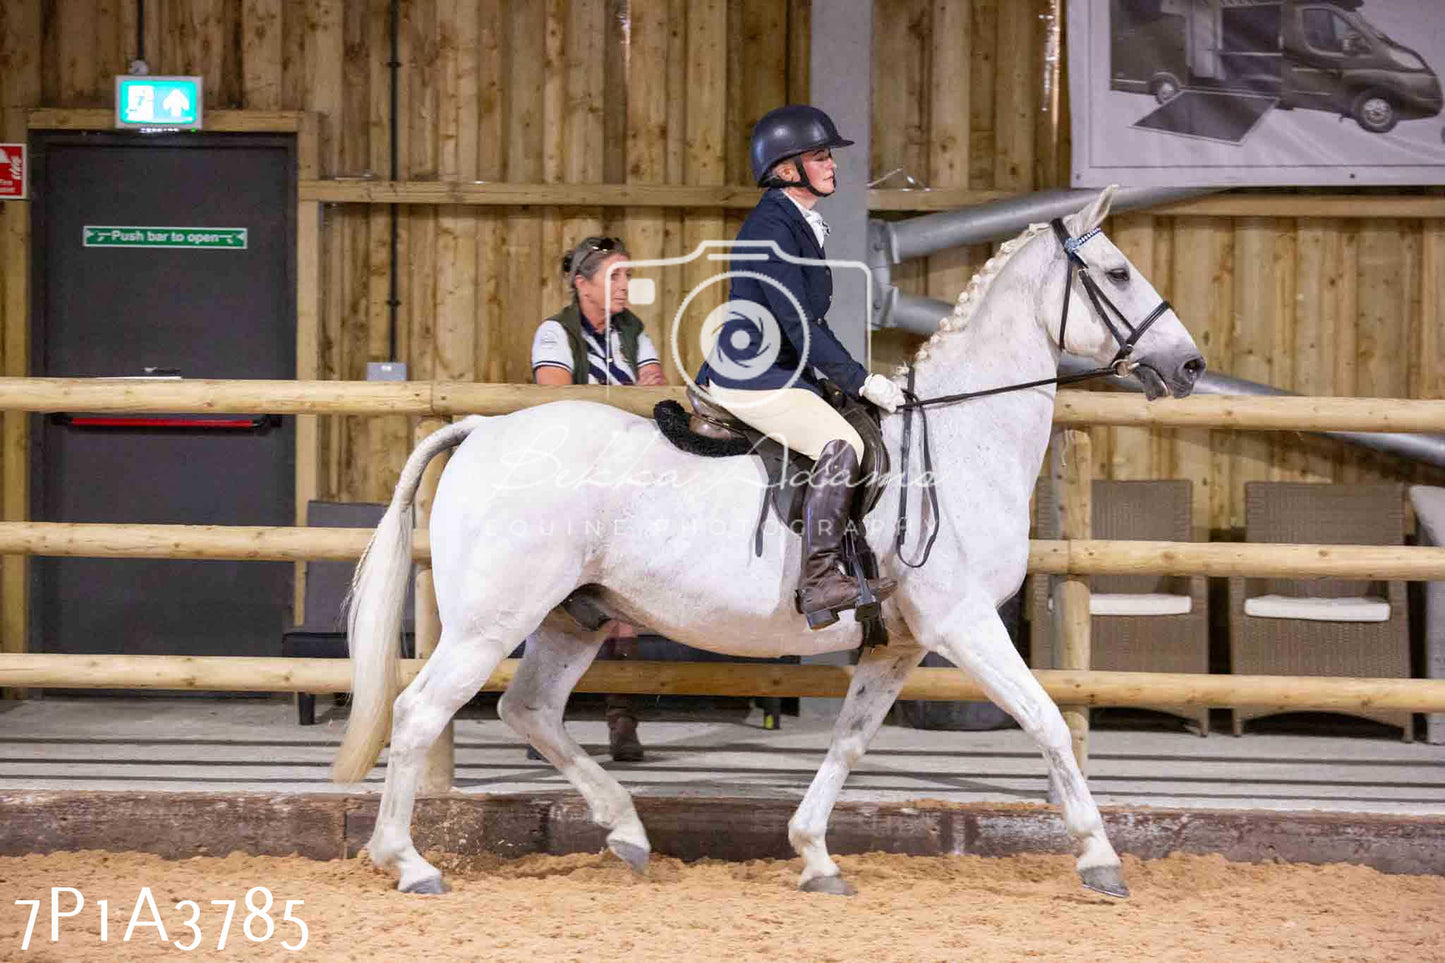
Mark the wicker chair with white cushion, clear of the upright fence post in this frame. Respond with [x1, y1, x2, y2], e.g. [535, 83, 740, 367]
[1230, 482, 1415, 742]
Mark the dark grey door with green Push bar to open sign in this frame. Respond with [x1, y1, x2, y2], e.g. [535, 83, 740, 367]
[32, 133, 296, 655]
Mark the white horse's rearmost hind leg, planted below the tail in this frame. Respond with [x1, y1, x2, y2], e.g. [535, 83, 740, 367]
[367, 626, 522, 894]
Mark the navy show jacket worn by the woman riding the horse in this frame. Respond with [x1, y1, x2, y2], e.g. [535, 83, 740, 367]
[696, 188, 868, 398]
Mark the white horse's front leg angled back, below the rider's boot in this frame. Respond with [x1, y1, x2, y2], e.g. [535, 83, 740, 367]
[788, 639, 923, 896]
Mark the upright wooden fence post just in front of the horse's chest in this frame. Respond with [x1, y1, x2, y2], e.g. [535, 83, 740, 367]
[1049, 428, 1094, 772]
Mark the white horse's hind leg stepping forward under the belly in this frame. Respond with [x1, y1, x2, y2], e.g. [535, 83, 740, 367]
[497, 616, 652, 873]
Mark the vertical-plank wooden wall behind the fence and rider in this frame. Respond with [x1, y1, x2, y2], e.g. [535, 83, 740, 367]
[0, 0, 1445, 529]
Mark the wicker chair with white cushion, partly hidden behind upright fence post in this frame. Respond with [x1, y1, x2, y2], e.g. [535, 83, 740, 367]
[1027, 480, 1209, 736]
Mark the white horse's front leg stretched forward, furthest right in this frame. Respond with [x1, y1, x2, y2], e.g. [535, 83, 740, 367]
[913, 600, 1129, 898]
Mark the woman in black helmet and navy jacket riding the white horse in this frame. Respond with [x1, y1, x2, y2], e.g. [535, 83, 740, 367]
[696, 104, 903, 629]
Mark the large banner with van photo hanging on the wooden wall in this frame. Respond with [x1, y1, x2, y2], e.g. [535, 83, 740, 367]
[1068, 0, 1445, 187]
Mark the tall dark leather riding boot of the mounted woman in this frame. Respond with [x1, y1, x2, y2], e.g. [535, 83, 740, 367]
[798, 440, 897, 629]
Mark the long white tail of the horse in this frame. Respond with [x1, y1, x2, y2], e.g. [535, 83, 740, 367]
[331, 418, 481, 782]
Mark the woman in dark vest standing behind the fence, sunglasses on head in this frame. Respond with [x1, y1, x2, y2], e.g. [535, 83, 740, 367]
[527, 237, 668, 762]
